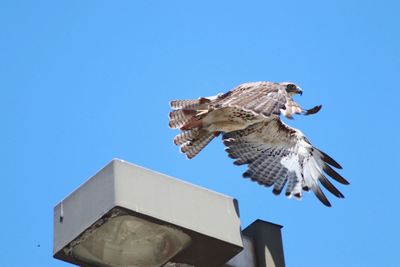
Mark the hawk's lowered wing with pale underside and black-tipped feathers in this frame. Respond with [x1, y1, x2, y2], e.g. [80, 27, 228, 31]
[223, 118, 349, 206]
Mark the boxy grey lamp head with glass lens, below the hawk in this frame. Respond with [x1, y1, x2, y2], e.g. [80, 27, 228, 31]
[54, 159, 243, 267]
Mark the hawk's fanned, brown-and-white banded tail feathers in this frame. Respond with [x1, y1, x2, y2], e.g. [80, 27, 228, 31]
[169, 98, 219, 159]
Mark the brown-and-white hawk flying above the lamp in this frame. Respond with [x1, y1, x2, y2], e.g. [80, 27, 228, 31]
[169, 81, 349, 207]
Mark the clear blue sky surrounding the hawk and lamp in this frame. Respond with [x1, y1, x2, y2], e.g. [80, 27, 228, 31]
[0, 0, 400, 267]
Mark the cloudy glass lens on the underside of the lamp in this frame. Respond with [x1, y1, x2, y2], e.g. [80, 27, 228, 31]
[66, 208, 191, 267]
